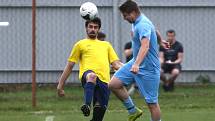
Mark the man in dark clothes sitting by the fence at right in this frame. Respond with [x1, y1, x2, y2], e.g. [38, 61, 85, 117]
[160, 29, 183, 91]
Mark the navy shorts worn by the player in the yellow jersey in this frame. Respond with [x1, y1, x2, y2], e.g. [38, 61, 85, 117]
[81, 70, 110, 107]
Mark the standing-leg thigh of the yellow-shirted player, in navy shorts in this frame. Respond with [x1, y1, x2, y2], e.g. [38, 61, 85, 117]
[93, 79, 110, 107]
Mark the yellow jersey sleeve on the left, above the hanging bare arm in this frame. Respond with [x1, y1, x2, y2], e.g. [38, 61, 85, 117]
[68, 43, 81, 63]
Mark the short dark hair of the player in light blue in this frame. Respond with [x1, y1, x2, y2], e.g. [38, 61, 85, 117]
[119, 0, 140, 14]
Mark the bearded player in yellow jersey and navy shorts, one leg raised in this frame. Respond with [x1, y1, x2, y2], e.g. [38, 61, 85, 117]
[57, 18, 123, 121]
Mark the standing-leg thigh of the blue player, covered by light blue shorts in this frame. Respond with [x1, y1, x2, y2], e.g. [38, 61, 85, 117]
[135, 72, 160, 103]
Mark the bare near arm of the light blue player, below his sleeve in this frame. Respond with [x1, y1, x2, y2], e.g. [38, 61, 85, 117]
[130, 38, 149, 73]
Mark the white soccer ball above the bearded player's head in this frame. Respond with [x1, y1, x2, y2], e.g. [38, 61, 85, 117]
[80, 2, 98, 20]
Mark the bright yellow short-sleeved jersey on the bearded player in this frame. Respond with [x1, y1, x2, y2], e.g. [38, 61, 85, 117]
[68, 39, 119, 83]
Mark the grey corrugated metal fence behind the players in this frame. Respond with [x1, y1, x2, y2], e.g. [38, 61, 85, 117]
[0, 0, 215, 83]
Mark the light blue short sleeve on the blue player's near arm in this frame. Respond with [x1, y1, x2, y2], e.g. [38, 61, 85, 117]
[137, 23, 152, 40]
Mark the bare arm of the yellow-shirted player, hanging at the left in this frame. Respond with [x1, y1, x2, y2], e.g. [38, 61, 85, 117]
[57, 62, 75, 97]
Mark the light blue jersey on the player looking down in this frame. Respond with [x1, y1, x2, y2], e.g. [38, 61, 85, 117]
[130, 14, 160, 73]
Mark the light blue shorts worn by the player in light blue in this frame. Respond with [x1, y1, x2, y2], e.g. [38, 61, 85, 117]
[114, 63, 160, 104]
